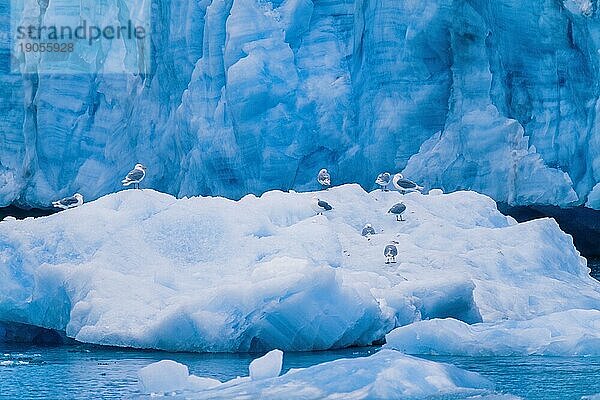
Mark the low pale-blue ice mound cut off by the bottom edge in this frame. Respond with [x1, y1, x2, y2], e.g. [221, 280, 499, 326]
[140, 350, 496, 399]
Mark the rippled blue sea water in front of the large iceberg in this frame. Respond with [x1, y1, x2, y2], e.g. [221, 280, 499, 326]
[0, 344, 600, 400]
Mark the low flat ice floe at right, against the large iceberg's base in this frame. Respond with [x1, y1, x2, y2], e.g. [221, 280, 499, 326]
[386, 310, 600, 356]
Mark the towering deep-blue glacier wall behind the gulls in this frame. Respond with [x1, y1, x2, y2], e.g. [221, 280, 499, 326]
[0, 0, 600, 205]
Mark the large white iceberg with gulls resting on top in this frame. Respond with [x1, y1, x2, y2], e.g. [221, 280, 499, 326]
[0, 185, 600, 351]
